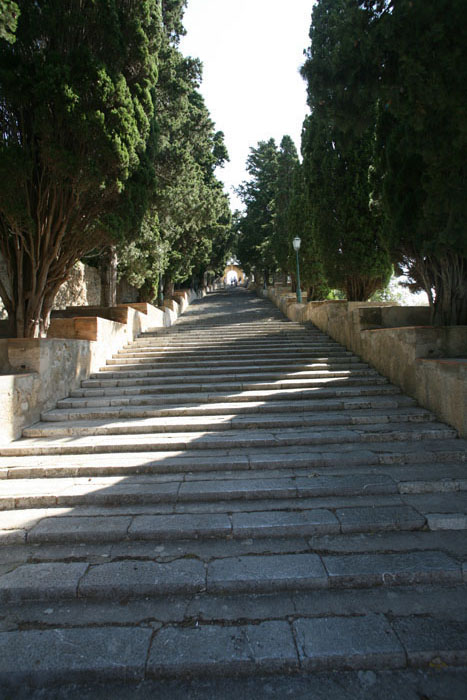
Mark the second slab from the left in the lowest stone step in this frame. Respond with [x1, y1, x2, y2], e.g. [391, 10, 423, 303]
[147, 621, 298, 678]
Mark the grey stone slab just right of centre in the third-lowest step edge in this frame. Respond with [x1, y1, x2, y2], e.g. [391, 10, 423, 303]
[232, 510, 340, 537]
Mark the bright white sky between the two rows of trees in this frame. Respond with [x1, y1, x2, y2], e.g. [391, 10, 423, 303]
[180, 0, 314, 209]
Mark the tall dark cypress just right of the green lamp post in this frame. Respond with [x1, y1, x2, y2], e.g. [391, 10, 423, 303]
[302, 0, 391, 301]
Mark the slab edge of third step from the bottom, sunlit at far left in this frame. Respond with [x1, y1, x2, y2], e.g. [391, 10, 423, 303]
[0, 501, 432, 546]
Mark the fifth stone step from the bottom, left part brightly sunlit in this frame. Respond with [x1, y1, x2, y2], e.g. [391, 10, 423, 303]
[0, 440, 466, 482]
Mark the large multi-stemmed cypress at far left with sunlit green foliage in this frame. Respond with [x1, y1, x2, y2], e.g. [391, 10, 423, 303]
[0, 0, 160, 336]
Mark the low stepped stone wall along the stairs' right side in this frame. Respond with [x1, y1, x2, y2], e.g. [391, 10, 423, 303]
[266, 288, 467, 437]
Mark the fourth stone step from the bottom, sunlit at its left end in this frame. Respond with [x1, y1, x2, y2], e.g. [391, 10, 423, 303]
[0, 470, 467, 516]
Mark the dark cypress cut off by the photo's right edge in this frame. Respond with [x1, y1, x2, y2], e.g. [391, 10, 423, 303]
[375, 0, 467, 325]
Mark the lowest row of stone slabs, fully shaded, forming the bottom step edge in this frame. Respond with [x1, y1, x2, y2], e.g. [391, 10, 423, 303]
[0, 614, 467, 697]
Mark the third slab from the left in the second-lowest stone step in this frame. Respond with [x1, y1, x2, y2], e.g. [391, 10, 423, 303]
[207, 554, 328, 592]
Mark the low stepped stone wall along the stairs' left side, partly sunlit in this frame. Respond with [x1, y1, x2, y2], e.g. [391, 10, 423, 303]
[0, 290, 196, 442]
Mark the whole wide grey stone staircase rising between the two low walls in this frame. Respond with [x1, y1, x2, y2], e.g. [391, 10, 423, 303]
[0, 289, 467, 700]
